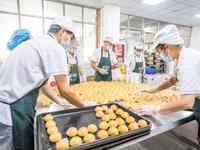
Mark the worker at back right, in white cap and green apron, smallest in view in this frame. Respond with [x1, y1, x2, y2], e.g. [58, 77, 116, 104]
[124, 42, 146, 75]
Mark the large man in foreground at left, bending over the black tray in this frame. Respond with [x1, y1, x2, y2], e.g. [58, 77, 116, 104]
[0, 17, 84, 150]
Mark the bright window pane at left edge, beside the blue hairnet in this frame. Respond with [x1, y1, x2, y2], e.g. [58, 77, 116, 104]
[0, 13, 18, 59]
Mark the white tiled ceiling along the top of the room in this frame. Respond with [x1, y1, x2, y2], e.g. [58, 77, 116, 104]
[59, 0, 200, 26]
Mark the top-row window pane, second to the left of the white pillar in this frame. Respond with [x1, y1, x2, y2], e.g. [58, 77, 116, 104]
[65, 5, 82, 22]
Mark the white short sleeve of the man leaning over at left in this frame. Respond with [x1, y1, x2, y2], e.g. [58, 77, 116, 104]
[42, 49, 68, 76]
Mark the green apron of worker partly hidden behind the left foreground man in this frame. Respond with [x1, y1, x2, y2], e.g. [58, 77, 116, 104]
[66, 52, 80, 85]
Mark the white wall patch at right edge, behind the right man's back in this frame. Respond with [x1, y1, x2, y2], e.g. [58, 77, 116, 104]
[190, 26, 200, 51]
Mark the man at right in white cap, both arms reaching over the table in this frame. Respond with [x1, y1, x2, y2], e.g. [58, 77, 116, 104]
[136, 25, 200, 142]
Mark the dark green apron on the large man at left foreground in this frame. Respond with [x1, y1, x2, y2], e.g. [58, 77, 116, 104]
[0, 80, 47, 150]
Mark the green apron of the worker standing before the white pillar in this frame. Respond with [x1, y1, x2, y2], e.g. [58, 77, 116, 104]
[94, 47, 112, 82]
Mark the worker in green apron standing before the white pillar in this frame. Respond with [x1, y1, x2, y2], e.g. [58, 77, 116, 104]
[90, 36, 119, 82]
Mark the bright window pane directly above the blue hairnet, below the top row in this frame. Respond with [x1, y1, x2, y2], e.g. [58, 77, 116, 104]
[21, 16, 43, 38]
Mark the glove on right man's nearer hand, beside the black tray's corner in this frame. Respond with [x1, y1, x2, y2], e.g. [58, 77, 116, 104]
[135, 106, 160, 116]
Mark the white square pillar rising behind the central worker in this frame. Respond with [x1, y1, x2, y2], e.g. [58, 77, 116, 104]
[100, 5, 120, 45]
